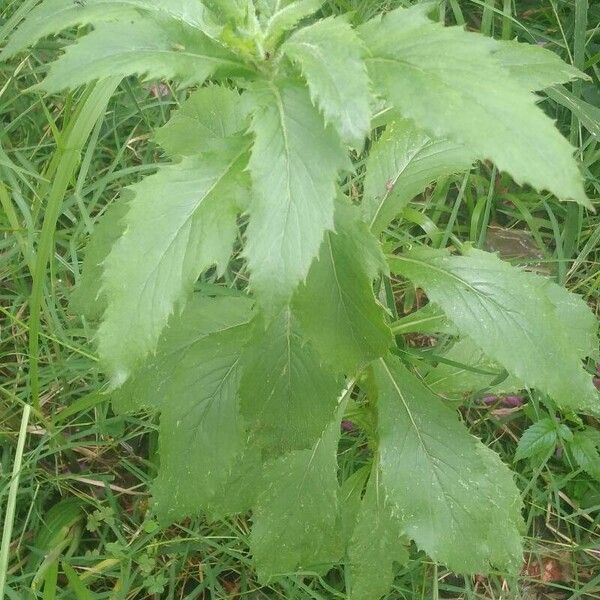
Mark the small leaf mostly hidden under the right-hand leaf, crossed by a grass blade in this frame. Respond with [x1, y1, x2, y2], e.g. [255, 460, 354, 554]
[423, 338, 526, 395]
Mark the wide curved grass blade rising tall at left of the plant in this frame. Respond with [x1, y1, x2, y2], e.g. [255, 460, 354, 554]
[29, 78, 120, 410]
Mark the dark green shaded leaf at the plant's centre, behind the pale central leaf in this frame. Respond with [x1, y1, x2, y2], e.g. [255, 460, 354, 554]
[293, 202, 393, 374]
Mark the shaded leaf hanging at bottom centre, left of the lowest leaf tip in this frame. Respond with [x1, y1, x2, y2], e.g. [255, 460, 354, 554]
[250, 415, 341, 581]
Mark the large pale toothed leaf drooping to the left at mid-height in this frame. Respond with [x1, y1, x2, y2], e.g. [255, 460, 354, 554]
[98, 146, 247, 385]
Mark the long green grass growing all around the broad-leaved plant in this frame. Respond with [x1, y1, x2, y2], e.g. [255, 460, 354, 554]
[0, 0, 600, 600]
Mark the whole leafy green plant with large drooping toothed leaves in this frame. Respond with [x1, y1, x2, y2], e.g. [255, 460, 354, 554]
[2, 0, 600, 598]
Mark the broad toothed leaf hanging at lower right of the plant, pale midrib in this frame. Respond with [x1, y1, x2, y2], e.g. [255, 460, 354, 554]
[374, 357, 522, 573]
